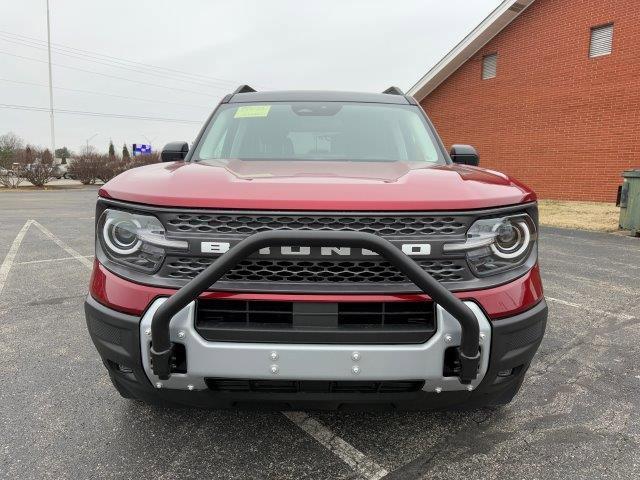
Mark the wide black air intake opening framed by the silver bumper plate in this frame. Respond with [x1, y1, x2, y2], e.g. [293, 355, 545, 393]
[195, 299, 436, 343]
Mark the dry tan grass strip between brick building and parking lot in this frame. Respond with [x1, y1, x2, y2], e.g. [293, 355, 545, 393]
[538, 200, 620, 232]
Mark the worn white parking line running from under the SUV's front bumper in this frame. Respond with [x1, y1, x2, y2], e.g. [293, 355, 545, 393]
[282, 412, 389, 480]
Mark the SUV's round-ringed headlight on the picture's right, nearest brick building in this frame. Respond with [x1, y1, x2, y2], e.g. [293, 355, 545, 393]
[444, 214, 537, 277]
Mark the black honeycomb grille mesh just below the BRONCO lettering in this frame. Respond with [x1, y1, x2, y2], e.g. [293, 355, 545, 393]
[161, 257, 471, 284]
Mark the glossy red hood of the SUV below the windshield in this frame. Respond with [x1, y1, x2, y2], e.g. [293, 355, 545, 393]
[99, 160, 536, 211]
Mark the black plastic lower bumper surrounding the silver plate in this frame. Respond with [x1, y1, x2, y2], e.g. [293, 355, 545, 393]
[85, 297, 547, 410]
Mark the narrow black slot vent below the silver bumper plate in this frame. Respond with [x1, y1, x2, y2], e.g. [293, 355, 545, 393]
[205, 378, 424, 393]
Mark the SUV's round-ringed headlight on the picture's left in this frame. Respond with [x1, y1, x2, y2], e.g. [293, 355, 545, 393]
[96, 209, 189, 273]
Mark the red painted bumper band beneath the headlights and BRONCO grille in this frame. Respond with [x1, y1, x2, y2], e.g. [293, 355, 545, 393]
[90, 260, 542, 319]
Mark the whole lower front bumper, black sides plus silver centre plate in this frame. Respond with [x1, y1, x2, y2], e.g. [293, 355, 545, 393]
[85, 297, 547, 409]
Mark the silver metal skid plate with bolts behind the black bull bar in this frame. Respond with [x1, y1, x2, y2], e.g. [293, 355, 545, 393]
[140, 298, 491, 391]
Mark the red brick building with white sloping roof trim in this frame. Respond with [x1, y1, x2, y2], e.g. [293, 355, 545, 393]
[409, 0, 640, 202]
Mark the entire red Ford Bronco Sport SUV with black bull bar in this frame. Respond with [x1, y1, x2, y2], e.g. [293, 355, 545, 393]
[85, 85, 547, 409]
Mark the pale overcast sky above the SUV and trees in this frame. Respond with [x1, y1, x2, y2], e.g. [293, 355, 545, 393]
[0, 0, 500, 151]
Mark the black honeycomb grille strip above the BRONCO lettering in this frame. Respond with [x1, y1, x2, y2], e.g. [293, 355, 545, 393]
[162, 213, 469, 237]
